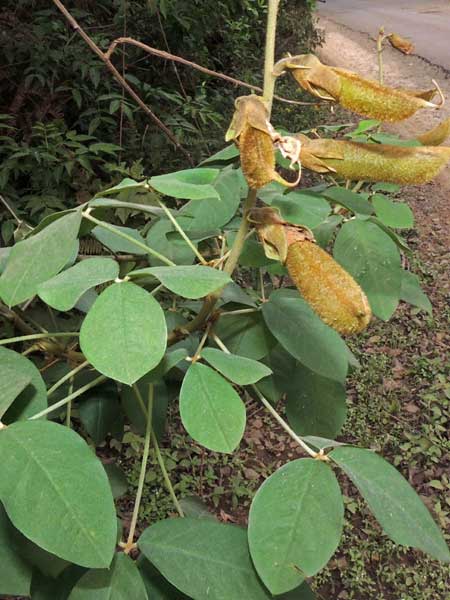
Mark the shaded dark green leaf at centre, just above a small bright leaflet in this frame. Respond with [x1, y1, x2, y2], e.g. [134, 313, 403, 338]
[214, 312, 276, 360]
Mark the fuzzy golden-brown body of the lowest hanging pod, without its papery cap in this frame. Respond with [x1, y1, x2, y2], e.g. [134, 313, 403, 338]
[286, 241, 372, 335]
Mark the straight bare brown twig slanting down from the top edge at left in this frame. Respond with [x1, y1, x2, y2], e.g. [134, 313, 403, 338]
[52, 0, 194, 166]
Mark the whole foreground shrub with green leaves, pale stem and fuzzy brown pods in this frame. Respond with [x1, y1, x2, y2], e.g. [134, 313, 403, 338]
[0, 0, 450, 600]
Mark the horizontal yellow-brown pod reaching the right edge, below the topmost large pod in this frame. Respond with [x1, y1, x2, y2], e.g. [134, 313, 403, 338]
[300, 136, 450, 185]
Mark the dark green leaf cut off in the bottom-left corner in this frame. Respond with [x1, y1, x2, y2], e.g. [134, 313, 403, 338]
[0, 504, 31, 596]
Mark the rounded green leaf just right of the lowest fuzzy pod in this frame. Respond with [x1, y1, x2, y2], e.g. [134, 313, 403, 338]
[333, 220, 401, 321]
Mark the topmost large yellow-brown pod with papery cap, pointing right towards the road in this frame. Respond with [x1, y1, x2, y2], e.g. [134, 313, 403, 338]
[274, 54, 442, 121]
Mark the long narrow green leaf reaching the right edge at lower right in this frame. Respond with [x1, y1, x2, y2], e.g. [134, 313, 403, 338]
[329, 446, 450, 562]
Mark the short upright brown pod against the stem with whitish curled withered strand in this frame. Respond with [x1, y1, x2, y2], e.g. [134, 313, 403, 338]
[225, 95, 301, 189]
